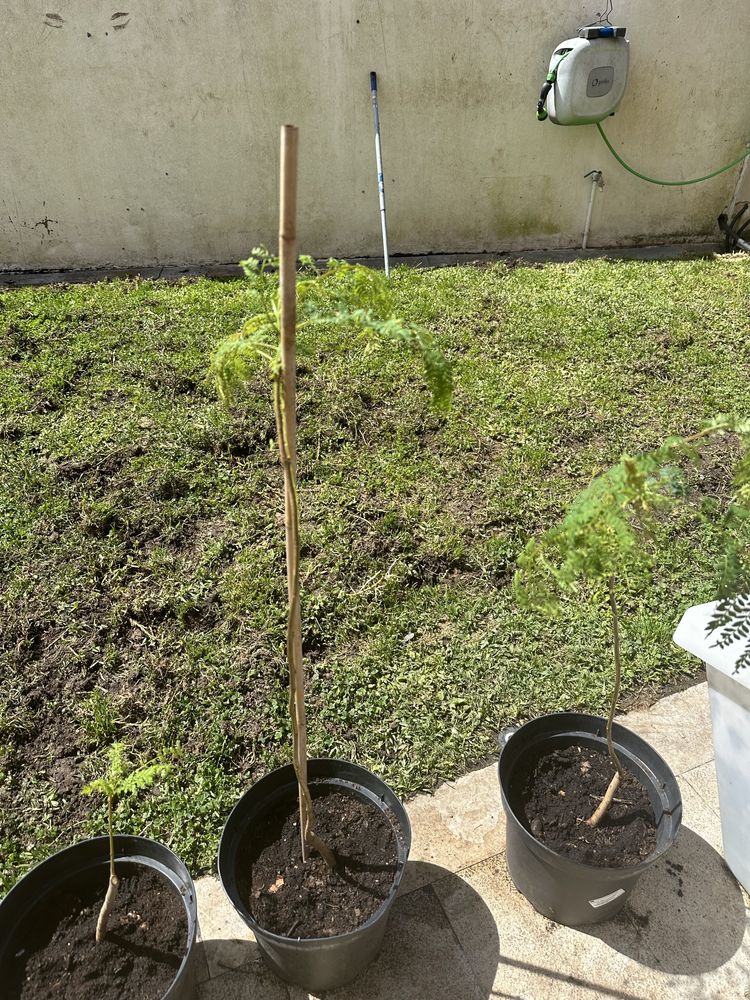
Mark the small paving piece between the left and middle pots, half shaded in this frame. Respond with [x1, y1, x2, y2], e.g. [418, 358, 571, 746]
[195, 875, 259, 978]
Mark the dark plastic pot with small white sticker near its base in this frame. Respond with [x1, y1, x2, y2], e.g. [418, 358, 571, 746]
[498, 712, 682, 926]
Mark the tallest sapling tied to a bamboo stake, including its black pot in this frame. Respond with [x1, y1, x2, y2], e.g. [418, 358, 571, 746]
[213, 126, 451, 992]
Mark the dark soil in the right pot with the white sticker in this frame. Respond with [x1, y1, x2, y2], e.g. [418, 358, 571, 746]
[519, 746, 656, 868]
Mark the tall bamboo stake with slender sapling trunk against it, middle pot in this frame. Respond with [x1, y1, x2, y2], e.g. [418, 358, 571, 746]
[274, 125, 336, 868]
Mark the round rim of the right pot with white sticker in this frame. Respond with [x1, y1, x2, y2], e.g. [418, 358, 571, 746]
[497, 712, 682, 880]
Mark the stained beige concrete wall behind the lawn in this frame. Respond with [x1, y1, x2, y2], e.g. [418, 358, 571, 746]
[0, 0, 750, 268]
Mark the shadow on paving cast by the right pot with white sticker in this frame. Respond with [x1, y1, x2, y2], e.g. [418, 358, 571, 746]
[579, 826, 747, 976]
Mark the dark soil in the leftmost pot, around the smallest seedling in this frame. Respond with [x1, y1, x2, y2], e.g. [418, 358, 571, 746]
[7, 865, 187, 1000]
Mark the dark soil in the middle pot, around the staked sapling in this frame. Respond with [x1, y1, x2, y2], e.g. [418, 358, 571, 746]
[238, 785, 398, 938]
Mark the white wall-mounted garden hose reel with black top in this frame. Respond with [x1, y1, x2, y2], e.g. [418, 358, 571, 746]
[536, 25, 630, 125]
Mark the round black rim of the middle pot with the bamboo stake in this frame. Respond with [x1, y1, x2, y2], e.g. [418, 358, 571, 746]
[216, 757, 411, 948]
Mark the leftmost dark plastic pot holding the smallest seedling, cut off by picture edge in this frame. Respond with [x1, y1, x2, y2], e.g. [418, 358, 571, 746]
[0, 836, 198, 1000]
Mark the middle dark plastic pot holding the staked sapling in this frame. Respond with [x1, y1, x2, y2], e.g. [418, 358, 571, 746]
[218, 757, 411, 993]
